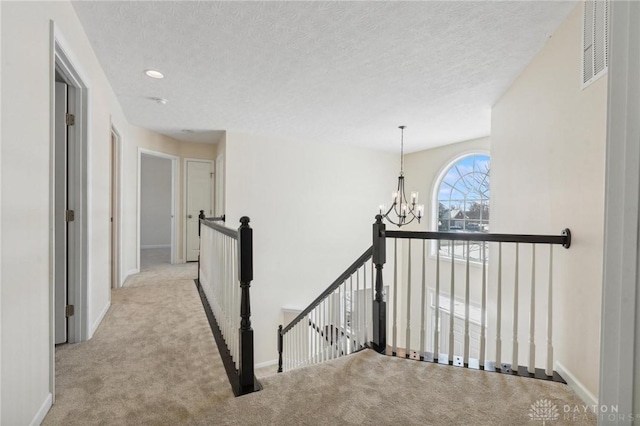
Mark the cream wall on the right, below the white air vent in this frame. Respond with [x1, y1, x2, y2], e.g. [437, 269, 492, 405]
[491, 4, 607, 399]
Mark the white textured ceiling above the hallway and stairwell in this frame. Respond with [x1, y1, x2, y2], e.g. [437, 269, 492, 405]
[74, 1, 576, 152]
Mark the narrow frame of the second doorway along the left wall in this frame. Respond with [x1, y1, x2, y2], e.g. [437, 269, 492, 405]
[109, 123, 122, 288]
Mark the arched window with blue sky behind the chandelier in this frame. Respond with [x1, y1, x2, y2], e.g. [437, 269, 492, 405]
[434, 154, 491, 260]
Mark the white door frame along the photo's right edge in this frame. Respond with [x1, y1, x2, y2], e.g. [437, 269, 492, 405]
[598, 2, 640, 424]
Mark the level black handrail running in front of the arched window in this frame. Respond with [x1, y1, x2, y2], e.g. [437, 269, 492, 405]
[381, 228, 571, 248]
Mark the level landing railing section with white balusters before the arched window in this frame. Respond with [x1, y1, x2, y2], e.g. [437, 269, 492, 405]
[373, 216, 571, 381]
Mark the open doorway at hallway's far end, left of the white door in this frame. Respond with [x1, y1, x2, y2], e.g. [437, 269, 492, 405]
[138, 150, 177, 271]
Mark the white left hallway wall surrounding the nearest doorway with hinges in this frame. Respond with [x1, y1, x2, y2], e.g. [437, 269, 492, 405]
[0, 2, 128, 425]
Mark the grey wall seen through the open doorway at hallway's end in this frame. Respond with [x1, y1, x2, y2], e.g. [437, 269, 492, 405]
[140, 154, 171, 248]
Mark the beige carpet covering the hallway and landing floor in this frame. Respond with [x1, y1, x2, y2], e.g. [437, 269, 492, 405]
[44, 250, 596, 425]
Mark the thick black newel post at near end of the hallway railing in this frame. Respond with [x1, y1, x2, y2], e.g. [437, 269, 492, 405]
[238, 216, 253, 392]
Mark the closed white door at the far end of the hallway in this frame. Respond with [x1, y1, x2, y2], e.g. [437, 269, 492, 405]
[186, 160, 213, 262]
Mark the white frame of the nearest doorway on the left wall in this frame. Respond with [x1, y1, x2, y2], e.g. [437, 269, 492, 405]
[49, 21, 91, 401]
